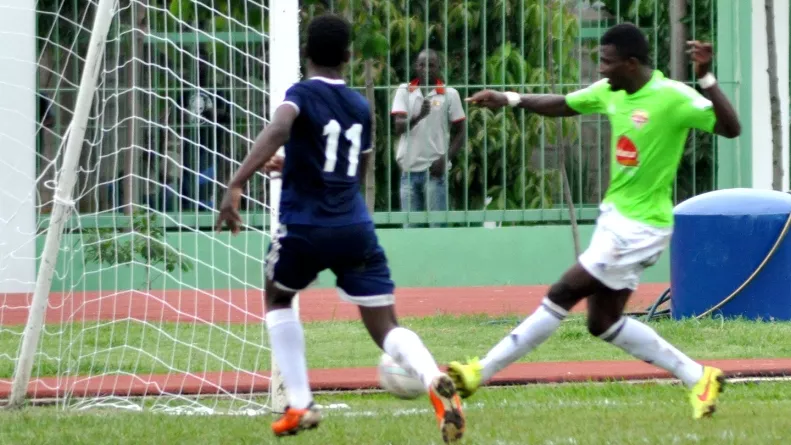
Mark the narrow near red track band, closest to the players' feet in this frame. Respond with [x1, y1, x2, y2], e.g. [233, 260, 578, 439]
[0, 359, 791, 398]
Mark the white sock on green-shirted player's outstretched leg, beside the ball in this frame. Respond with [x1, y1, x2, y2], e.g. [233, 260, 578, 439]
[481, 298, 568, 383]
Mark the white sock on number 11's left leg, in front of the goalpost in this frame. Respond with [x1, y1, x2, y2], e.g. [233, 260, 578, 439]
[266, 309, 313, 409]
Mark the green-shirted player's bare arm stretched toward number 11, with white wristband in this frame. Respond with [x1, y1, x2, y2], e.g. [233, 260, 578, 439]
[465, 90, 579, 117]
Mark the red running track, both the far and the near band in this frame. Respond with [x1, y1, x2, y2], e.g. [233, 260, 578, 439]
[0, 284, 791, 398]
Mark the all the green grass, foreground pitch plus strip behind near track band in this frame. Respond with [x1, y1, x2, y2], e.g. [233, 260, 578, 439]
[0, 316, 791, 445]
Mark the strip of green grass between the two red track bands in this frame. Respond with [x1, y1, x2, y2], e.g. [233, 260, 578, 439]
[6, 316, 791, 378]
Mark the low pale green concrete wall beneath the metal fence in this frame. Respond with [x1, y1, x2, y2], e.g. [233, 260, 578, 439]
[46, 225, 670, 291]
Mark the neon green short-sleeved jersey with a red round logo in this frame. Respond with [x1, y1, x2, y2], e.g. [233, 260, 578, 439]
[566, 71, 716, 227]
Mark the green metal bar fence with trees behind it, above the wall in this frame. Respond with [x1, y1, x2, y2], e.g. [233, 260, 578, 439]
[38, 0, 728, 227]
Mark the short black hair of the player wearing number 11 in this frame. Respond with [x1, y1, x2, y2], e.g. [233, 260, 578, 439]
[306, 14, 351, 67]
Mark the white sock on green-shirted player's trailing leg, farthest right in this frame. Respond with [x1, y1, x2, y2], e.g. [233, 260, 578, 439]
[599, 317, 703, 387]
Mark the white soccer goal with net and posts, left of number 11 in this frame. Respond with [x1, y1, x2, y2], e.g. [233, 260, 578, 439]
[0, 0, 299, 413]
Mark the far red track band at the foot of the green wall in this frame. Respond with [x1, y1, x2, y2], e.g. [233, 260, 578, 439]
[0, 284, 667, 326]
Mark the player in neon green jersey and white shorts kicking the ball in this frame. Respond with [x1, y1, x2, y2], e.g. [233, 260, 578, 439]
[449, 24, 741, 418]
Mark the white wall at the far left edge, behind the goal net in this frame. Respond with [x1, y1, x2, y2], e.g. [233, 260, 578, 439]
[0, 0, 38, 294]
